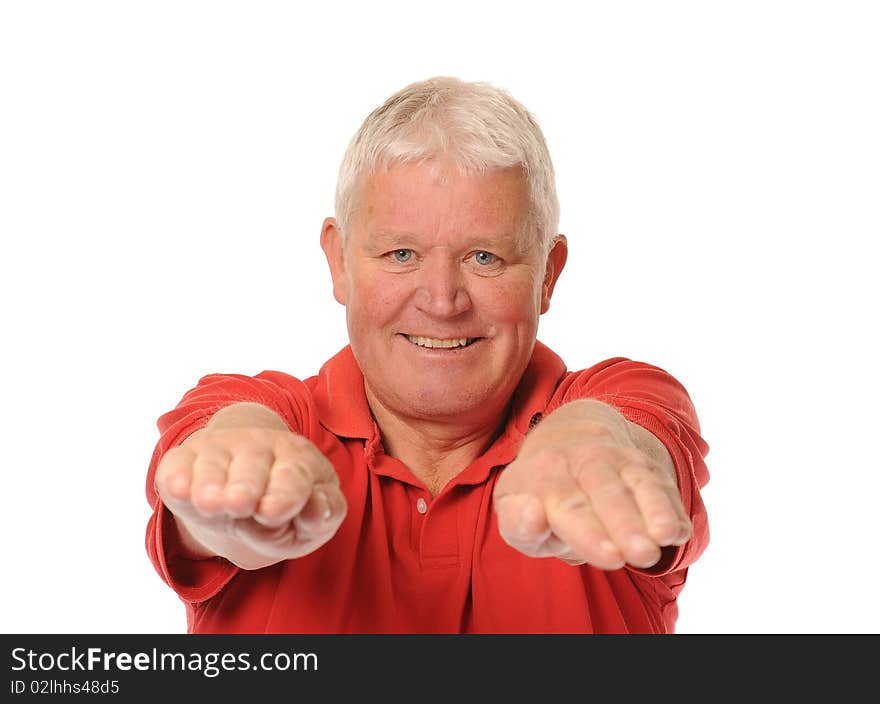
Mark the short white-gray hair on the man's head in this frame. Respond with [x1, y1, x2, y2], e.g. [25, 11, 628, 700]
[335, 76, 559, 256]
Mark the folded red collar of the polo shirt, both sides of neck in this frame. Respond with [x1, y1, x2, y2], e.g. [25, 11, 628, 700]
[313, 341, 566, 440]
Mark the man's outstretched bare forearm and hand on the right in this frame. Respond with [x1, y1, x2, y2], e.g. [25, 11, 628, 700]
[494, 399, 693, 570]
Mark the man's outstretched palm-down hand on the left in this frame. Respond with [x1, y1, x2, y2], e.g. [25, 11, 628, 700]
[156, 424, 347, 570]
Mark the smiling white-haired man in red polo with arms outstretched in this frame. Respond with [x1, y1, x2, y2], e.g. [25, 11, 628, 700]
[147, 78, 708, 633]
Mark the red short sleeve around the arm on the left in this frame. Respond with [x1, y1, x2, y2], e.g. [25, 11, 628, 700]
[146, 371, 315, 603]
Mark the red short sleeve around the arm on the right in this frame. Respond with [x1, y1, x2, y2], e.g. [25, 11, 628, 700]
[547, 358, 709, 573]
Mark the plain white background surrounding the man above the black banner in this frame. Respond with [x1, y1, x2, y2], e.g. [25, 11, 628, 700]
[0, 0, 880, 633]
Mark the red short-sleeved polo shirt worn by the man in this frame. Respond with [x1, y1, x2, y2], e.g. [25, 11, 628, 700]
[146, 342, 709, 633]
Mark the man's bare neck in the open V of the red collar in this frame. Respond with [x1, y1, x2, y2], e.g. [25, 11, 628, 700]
[367, 392, 506, 496]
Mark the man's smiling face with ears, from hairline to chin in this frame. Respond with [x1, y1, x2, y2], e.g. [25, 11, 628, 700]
[322, 164, 566, 424]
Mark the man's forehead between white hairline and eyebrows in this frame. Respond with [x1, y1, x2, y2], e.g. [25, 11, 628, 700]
[355, 162, 529, 239]
